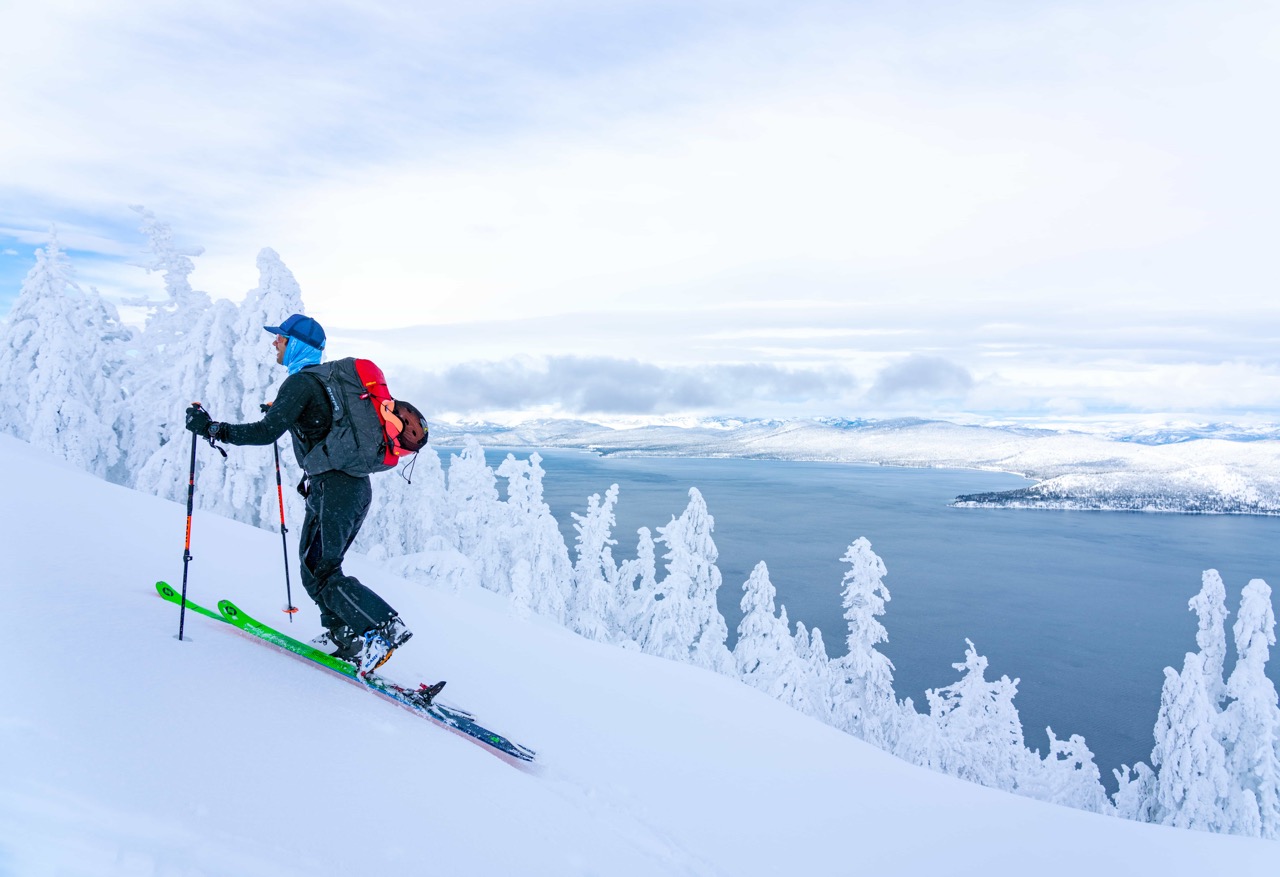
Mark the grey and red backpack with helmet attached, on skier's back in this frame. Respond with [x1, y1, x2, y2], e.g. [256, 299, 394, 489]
[293, 357, 426, 478]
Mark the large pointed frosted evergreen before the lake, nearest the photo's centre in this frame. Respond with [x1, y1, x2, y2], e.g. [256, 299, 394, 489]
[658, 488, 733, 675]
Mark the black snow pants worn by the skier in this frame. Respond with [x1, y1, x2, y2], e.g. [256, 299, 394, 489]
[298, 471, 396, 634]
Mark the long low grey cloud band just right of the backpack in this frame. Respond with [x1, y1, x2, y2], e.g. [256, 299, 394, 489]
[398, 356, 856, 415]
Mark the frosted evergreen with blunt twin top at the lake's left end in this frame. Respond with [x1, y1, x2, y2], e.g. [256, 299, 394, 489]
[498, 453, 573, 624]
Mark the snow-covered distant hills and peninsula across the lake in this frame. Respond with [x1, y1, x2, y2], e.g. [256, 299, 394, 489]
[431, 417, 1280, 515]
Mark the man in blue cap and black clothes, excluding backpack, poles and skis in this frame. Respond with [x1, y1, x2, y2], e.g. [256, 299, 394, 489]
[187, 314, 416, 675]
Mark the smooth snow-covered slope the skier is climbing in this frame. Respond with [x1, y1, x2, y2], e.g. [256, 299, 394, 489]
[0, 437, 1280, 877]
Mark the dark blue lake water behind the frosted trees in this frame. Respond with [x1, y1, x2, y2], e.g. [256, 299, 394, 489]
[465, 451, 1280, 787]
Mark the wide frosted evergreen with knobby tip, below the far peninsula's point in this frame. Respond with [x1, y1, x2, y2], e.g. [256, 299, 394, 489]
[925, 639, 1030, 791]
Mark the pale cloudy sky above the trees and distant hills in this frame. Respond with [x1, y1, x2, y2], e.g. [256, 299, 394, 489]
[0, 0, 1280, 421]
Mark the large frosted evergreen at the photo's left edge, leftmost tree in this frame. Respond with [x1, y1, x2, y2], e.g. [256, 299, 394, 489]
[0, 230, 131, 478]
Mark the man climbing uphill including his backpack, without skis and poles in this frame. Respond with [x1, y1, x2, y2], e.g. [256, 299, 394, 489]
[187, 314, 426, 673]
